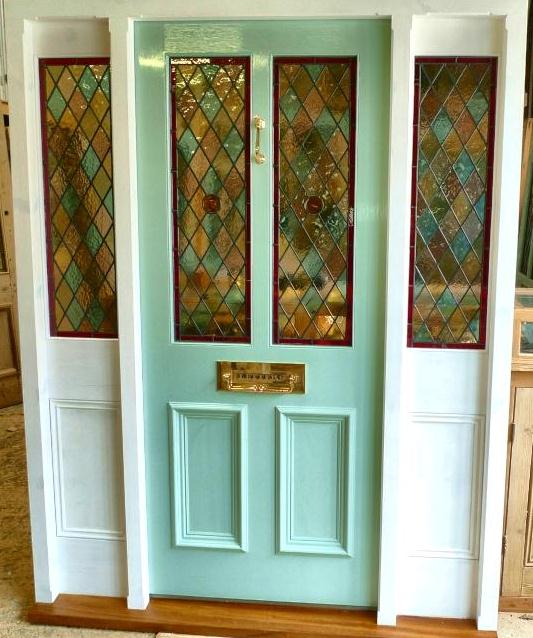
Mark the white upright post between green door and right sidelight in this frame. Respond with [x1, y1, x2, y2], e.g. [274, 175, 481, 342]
[378, 15, 413, 625]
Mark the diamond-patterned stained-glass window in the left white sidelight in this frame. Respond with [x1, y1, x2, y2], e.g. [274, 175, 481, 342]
[40, 59, 117, 337]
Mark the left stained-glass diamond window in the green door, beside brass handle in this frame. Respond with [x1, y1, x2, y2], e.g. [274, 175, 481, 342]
[171, 58, 250, 341]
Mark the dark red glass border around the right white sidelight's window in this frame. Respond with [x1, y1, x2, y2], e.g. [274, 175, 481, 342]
[407, 56, 498, 350]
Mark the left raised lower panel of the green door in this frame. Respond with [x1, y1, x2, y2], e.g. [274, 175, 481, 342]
[169, 403, 248, 551]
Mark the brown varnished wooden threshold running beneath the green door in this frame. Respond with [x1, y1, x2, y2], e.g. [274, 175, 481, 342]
[28, 594, 497, 638]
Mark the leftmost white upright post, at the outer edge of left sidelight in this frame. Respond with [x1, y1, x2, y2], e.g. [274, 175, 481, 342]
[7, 16, 58, 603]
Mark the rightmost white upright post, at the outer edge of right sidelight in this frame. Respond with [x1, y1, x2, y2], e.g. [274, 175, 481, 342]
[477, 8, 527, 631]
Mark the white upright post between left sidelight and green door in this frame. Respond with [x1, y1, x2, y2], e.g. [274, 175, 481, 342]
[109, 18, 150, 609]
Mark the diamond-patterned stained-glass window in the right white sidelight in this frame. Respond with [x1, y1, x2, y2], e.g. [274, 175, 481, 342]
[408, 58, 497, 348]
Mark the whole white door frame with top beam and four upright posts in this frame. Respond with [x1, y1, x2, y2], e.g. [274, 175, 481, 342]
[6, 0, 527, 629]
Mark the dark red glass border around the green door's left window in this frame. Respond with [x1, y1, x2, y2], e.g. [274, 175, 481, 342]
[169, 56, 252, 343]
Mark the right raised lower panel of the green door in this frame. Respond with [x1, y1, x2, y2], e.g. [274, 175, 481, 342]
[277, 408, 355, 556]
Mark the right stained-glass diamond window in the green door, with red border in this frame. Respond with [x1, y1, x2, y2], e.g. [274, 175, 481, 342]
[274, 58, 355, 345]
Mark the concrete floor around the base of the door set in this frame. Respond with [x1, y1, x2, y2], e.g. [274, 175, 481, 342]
[0, 406, 533, 638]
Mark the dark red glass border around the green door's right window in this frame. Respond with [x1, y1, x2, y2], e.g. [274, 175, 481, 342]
[272, 56, 357, 346]
